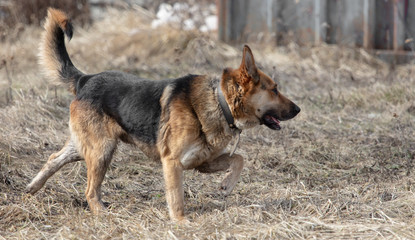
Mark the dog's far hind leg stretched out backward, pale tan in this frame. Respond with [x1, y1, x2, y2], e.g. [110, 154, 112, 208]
[26, 139, 82, 194]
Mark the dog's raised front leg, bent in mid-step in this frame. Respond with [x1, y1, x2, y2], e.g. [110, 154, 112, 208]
[196, 154, 244, 196]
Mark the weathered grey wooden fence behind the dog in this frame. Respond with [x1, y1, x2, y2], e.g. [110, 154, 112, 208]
[217, 0, 415, 51]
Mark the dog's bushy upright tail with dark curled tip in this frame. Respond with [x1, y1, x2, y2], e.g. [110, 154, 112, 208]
[39, 8, 84, 94]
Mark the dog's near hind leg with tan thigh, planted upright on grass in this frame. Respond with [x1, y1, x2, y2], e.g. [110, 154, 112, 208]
[69, 100, 123, 214]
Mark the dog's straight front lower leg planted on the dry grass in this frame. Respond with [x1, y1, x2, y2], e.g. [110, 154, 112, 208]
[162, 158, 185, 221]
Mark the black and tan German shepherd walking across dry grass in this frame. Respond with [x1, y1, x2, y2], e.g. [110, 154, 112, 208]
[26, 8, 300, 221]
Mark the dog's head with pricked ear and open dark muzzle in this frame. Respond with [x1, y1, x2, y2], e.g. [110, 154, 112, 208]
[221, 45, 300, 130]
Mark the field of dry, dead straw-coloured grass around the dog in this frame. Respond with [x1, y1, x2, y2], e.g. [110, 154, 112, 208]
[0, 9, 415, 239]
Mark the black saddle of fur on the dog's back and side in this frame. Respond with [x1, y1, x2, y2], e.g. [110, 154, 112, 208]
[76, 71, 172, 144]
